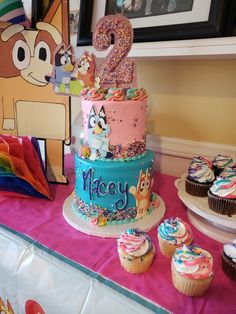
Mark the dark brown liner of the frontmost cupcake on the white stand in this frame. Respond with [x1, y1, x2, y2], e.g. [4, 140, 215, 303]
[207, 191, 236, 216]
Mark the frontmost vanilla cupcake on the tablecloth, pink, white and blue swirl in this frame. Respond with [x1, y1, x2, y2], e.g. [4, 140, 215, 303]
[171, 245, 214, 297]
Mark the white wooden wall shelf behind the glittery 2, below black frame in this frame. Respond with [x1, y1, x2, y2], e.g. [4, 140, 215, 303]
[76, 36, 236, 60]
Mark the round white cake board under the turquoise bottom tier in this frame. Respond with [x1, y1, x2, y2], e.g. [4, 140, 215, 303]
[63, 192, 166, 238]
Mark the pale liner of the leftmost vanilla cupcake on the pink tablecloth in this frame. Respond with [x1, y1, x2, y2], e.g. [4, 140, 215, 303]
[118, 244, 156, 274]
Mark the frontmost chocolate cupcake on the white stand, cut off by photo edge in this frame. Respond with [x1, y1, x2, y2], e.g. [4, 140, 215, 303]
[208, 177, 236, 216]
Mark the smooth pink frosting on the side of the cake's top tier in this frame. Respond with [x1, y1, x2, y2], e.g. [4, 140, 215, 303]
[81, 99, 147, 147]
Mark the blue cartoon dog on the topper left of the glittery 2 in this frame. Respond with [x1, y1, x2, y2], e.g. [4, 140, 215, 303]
[45, 44, 74, 94]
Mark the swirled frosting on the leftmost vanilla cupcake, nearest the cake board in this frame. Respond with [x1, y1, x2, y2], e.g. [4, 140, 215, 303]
[117, 229, 152, 257]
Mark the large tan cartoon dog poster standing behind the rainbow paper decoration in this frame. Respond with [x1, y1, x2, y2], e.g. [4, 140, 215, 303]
[0, 0, 70, 183]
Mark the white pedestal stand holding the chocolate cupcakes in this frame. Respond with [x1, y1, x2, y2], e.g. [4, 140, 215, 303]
[175, 174, 236, 243]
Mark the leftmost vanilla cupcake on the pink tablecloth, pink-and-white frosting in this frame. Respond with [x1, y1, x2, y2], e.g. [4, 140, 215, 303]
[117, 229, 155, 274]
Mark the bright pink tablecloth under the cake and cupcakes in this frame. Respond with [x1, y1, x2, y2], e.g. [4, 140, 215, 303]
[0, 156, 236, 314]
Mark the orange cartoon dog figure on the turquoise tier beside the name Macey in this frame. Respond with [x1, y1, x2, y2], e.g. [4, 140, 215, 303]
[129, 169, 153, 218]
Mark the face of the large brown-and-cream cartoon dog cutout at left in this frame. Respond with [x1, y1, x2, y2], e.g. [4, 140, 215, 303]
[0, 22, 62, 86]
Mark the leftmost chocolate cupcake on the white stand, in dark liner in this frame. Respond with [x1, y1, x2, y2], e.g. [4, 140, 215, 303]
[185, 157, 215, 197]
